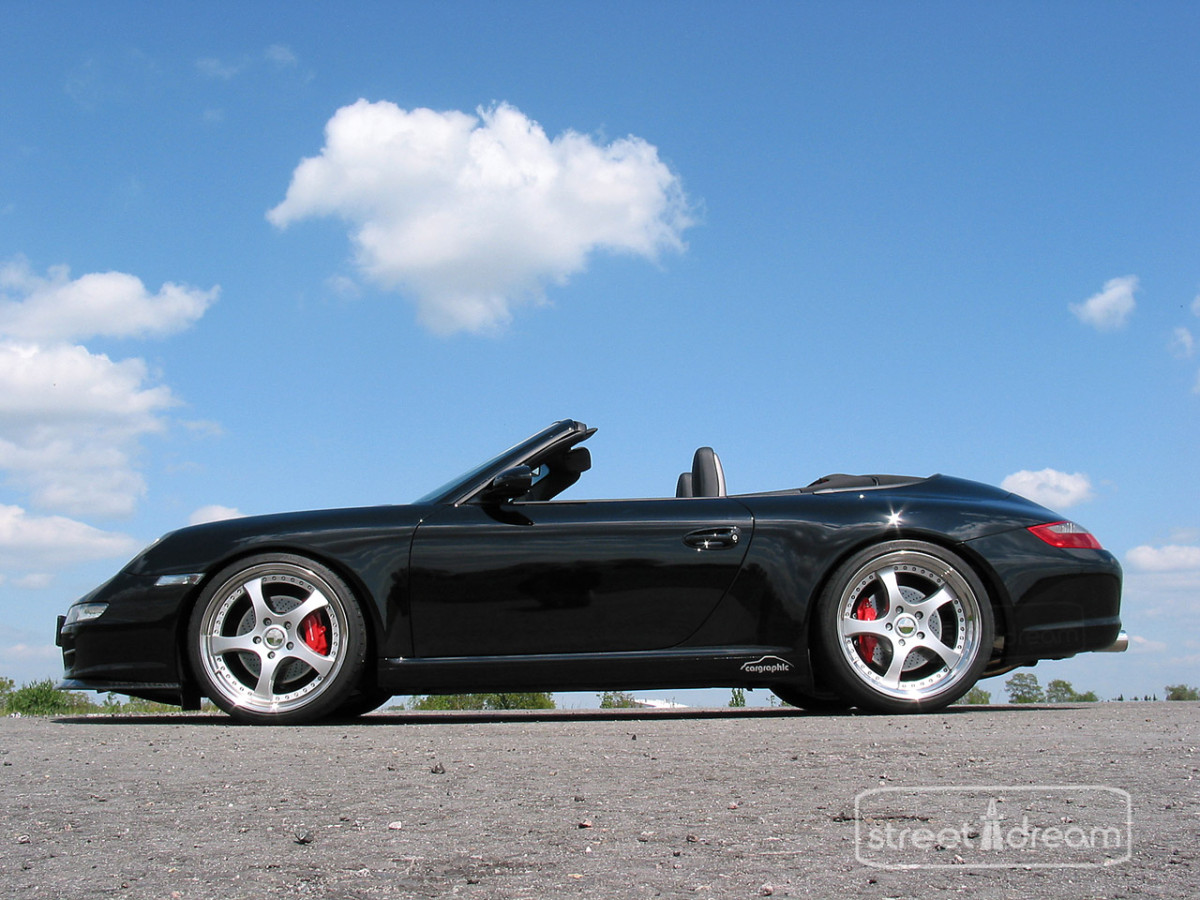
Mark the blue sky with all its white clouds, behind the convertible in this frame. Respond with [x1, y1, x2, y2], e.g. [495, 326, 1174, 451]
[0, 2, 1200, 697]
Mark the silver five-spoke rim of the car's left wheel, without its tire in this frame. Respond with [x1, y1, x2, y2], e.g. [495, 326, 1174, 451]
[197, 560, 349, 715]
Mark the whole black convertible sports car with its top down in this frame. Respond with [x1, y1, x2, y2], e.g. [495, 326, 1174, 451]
[56, 419, 1124, 722]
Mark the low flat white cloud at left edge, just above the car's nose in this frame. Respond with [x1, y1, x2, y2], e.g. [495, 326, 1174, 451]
[0, 504, 140, 572]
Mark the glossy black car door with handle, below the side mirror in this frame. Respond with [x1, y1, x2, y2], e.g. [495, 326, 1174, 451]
[409, 498, 752, 658]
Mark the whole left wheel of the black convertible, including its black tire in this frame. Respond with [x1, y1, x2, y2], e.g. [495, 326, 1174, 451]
[187, 553, 367, 725]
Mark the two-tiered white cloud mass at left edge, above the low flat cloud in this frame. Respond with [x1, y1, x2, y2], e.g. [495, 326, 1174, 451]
[0, 259, 217, 516]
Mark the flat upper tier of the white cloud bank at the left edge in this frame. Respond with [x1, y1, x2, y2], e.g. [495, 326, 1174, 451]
[0, 259, 213, 341]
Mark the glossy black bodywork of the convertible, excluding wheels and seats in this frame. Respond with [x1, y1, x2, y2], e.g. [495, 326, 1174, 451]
[58, 420, 1121, 704]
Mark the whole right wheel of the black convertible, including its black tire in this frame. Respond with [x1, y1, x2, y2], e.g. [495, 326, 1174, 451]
[814, 541, 995, 713]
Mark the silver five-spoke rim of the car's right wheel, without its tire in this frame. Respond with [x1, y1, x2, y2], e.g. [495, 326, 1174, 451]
[836, 550, 983, 701]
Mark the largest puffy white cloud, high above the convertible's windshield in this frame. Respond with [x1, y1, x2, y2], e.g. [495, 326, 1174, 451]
[268, 100, 692, 334]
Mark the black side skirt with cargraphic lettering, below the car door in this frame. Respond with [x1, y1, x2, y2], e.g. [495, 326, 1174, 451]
[378, 647, 802, 694]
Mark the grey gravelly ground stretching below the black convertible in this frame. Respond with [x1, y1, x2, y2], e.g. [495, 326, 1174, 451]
[0, 703, 1200, 900]
